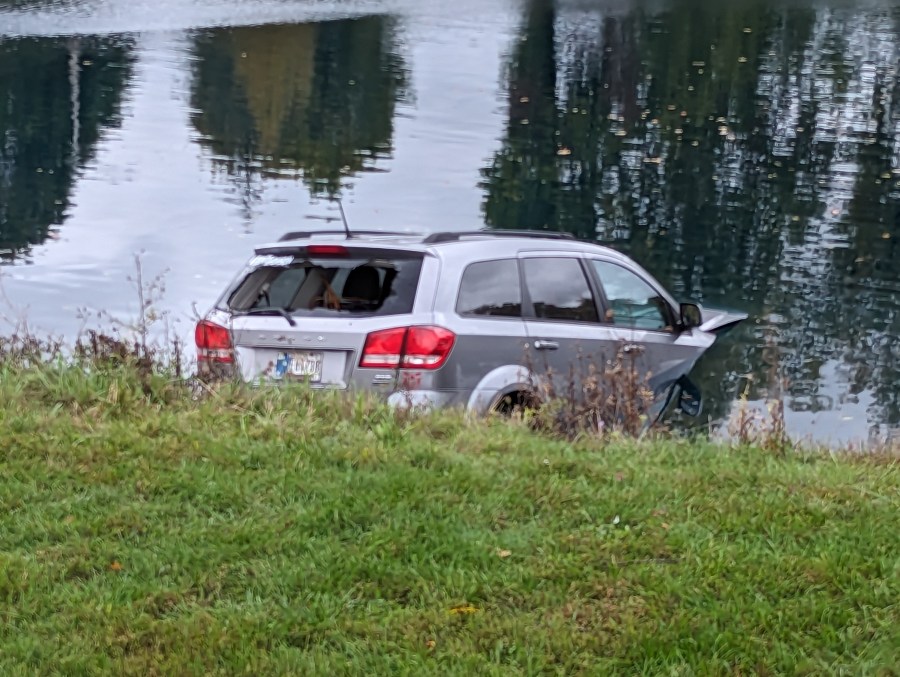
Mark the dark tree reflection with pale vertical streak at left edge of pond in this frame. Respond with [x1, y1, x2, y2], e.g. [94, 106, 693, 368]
[0, 36, 134, 259]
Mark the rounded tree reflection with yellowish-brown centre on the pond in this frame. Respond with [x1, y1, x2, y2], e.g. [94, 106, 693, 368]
[192, 16, 407, 214]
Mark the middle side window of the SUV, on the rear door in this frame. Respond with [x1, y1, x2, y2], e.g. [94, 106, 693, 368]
[525, 257, 599, 322]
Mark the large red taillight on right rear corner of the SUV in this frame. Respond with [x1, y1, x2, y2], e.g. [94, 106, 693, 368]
[359, 327, 456, 369]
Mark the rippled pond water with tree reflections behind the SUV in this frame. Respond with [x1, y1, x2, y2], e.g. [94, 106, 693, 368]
[0, 0, 900, 442]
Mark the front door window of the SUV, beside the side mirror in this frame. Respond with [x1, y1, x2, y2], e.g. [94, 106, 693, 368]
[591, 261, 672, 331]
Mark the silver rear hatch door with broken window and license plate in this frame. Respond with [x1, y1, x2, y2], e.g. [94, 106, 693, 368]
[223, 244, 424, 388]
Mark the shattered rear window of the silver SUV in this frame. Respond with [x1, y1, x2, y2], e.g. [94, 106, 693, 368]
[227, 247, 423, 316]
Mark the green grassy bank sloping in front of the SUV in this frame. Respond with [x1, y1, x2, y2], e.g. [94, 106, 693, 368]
[0, 360, 900, 675]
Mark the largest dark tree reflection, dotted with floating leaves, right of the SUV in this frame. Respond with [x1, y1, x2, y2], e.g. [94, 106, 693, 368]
[483, 0, 900, 438]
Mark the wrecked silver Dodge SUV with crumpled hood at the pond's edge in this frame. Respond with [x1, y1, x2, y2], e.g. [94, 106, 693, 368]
[196, 230, 746, 413]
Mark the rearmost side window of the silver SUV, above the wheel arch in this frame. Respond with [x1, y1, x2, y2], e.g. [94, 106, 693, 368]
[456, 259, 522, 317]
